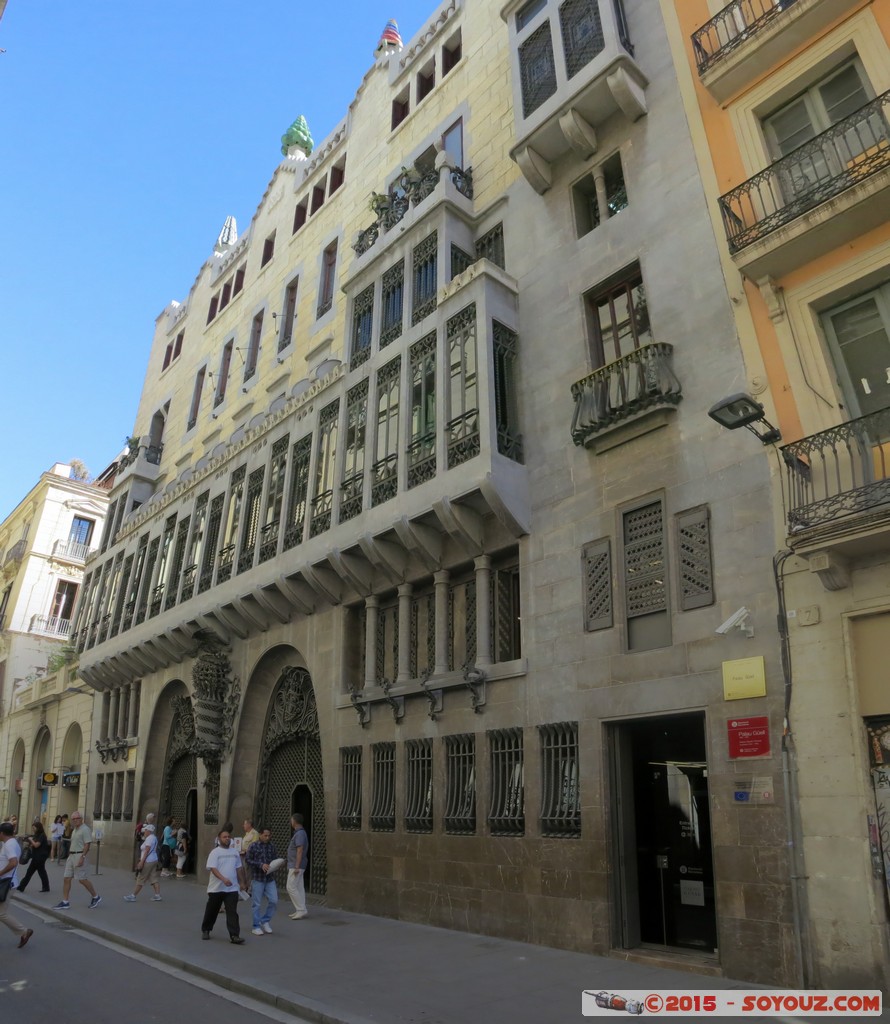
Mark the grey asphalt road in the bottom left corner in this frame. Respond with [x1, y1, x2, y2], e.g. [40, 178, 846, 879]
[0, 902, 313, 1024]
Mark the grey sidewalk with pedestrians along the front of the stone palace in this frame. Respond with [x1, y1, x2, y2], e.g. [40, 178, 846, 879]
[11, 864, 757, 1024]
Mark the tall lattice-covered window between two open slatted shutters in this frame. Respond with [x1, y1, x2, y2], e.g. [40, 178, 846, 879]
[622, 499, 671, 650]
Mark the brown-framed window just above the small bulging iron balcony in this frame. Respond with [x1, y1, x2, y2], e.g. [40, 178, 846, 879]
[585, 266, 652, 369]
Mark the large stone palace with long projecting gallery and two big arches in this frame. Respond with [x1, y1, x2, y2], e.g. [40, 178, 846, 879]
[76, 0, 801, 984]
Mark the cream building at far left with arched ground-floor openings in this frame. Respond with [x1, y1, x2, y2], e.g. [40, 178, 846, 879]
[0, 463, 109, 821]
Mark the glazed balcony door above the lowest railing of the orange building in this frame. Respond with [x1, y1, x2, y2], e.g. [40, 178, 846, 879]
[822, 284, 890, 417]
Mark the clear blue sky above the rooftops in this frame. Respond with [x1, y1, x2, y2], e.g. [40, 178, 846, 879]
[0, 0, 430, 521]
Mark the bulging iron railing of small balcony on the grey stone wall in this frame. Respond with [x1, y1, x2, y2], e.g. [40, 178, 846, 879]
[571, 342, 682, 445]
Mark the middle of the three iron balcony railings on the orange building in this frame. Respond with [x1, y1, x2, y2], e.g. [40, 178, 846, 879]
[720, 90, 890, 253]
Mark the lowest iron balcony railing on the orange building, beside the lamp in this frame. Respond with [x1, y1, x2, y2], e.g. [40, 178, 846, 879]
[780, 409, 890, 534]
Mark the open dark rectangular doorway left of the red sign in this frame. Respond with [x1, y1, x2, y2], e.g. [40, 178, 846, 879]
[610, 713, 717, 954]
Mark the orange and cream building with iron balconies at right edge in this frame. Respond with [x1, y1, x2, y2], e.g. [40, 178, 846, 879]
[661, 0, 890, 988]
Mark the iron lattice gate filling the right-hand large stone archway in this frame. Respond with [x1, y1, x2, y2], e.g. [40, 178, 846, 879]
[256, 668, 328, 896]
